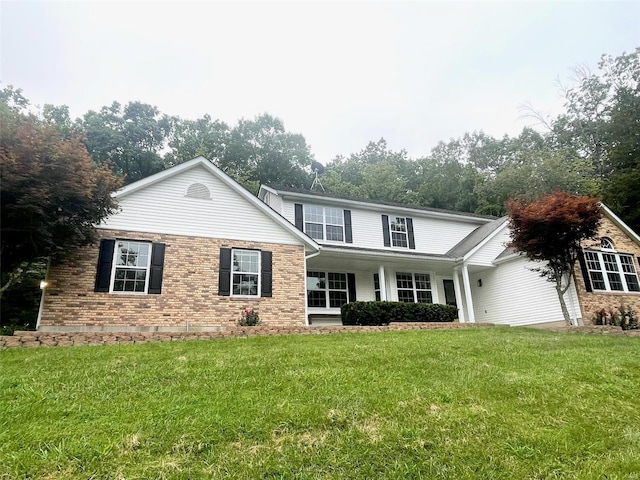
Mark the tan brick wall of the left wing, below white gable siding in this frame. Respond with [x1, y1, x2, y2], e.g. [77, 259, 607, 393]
[40, 230, 306, 329]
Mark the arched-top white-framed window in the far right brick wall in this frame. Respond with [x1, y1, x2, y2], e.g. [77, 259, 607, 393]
[584, 246, 640, 292]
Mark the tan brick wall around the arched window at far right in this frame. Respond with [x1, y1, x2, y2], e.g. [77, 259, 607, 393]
[575, 216, 640, 325]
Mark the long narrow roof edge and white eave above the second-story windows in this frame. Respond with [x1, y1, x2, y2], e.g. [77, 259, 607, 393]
[258, 185, 496, 223]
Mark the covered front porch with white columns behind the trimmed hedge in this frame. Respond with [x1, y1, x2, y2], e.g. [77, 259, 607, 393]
[306, 247, 475, 325]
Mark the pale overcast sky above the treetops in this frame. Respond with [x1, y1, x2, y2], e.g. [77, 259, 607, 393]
[0, 0, 640, 163]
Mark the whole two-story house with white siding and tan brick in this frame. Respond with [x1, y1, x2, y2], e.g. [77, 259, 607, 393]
[38, 157, 640, 331]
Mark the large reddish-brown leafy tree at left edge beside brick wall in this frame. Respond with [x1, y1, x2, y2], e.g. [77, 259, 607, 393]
[0, 86, 119, 295]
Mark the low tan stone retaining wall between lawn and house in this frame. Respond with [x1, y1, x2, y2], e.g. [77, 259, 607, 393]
[0, 323, 493, 348]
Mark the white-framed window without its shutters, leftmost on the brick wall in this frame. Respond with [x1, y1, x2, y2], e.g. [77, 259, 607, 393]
[110, 240, 151, 293]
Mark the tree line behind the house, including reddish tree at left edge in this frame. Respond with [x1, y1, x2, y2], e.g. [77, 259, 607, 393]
[0, 47, 640, 332]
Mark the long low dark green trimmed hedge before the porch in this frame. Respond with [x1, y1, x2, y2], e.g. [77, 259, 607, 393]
[340, 302, 458, 325]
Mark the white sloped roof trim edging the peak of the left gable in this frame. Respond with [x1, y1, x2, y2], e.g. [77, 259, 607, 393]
[112, 157, 320, 251]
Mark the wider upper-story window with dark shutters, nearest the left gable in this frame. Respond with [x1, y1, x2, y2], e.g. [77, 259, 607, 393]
[295, 203, 353, 243]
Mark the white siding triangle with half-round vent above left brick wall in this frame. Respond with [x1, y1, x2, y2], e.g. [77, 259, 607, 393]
[100, 167, 300, 245]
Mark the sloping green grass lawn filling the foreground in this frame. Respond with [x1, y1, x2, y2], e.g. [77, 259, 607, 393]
[0, 328, 640, 480]
